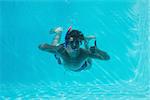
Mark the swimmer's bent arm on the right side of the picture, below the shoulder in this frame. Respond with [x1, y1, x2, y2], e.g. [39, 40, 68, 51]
[89, 46, 110, 60]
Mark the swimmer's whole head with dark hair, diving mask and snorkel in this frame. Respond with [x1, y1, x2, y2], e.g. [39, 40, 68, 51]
[65, 27, 84, 50]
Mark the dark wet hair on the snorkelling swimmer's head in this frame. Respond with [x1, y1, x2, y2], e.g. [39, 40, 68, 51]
[65, 30, 84, 46]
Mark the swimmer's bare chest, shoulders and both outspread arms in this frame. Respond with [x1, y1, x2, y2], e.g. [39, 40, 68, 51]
[39, 44, 110, 71]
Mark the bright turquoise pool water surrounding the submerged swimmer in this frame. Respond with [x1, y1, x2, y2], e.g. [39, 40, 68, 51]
[0, 0, 150, 100]
